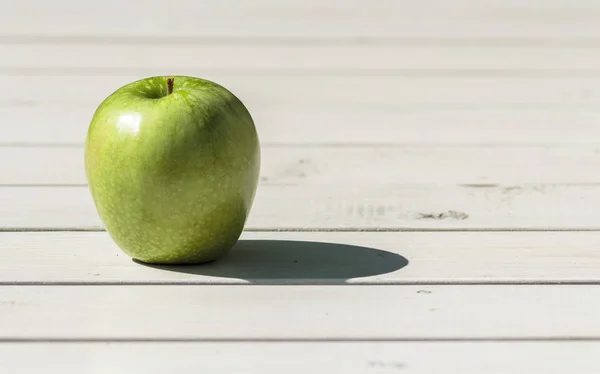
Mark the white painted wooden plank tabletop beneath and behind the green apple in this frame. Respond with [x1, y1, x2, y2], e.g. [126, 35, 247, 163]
[0, 0, 600, 374]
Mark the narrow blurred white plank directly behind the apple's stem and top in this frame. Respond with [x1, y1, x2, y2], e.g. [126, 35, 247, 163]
[8, 74, 600, 107]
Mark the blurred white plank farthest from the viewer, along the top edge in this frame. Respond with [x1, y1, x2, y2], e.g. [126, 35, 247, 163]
[0, 0, 600, 39]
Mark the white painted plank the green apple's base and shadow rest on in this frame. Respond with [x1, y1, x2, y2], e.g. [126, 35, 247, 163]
[0, 232, 600, 284]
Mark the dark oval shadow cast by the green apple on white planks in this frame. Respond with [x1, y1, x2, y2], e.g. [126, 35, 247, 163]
[136, 240, 408, 284]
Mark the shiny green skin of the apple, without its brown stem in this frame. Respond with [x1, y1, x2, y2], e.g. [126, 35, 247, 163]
[84, 76, 261, 265]
